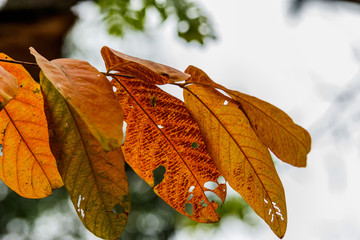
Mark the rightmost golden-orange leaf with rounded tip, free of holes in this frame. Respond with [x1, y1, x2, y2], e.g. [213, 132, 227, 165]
[185, 66, 311, 167]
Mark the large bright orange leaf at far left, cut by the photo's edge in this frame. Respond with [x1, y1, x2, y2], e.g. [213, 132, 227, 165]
[0, 54, 63, 198]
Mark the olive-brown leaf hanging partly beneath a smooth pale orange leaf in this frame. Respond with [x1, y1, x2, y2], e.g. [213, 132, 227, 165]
[40, 73, 130, 239]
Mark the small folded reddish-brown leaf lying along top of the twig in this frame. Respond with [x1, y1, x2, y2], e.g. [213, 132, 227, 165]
[101, 47, 190, 84]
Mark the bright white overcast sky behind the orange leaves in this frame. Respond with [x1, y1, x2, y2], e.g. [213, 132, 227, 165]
[67, 0, 360, 240]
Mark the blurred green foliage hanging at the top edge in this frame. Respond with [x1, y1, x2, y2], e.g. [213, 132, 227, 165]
[96, 0, 215, 44]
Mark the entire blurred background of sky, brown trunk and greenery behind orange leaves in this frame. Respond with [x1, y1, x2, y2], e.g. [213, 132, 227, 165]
[0, 0, 360, 240]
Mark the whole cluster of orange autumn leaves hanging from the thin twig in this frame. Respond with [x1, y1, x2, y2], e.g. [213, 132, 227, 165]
[0, 47, 311, 239]
